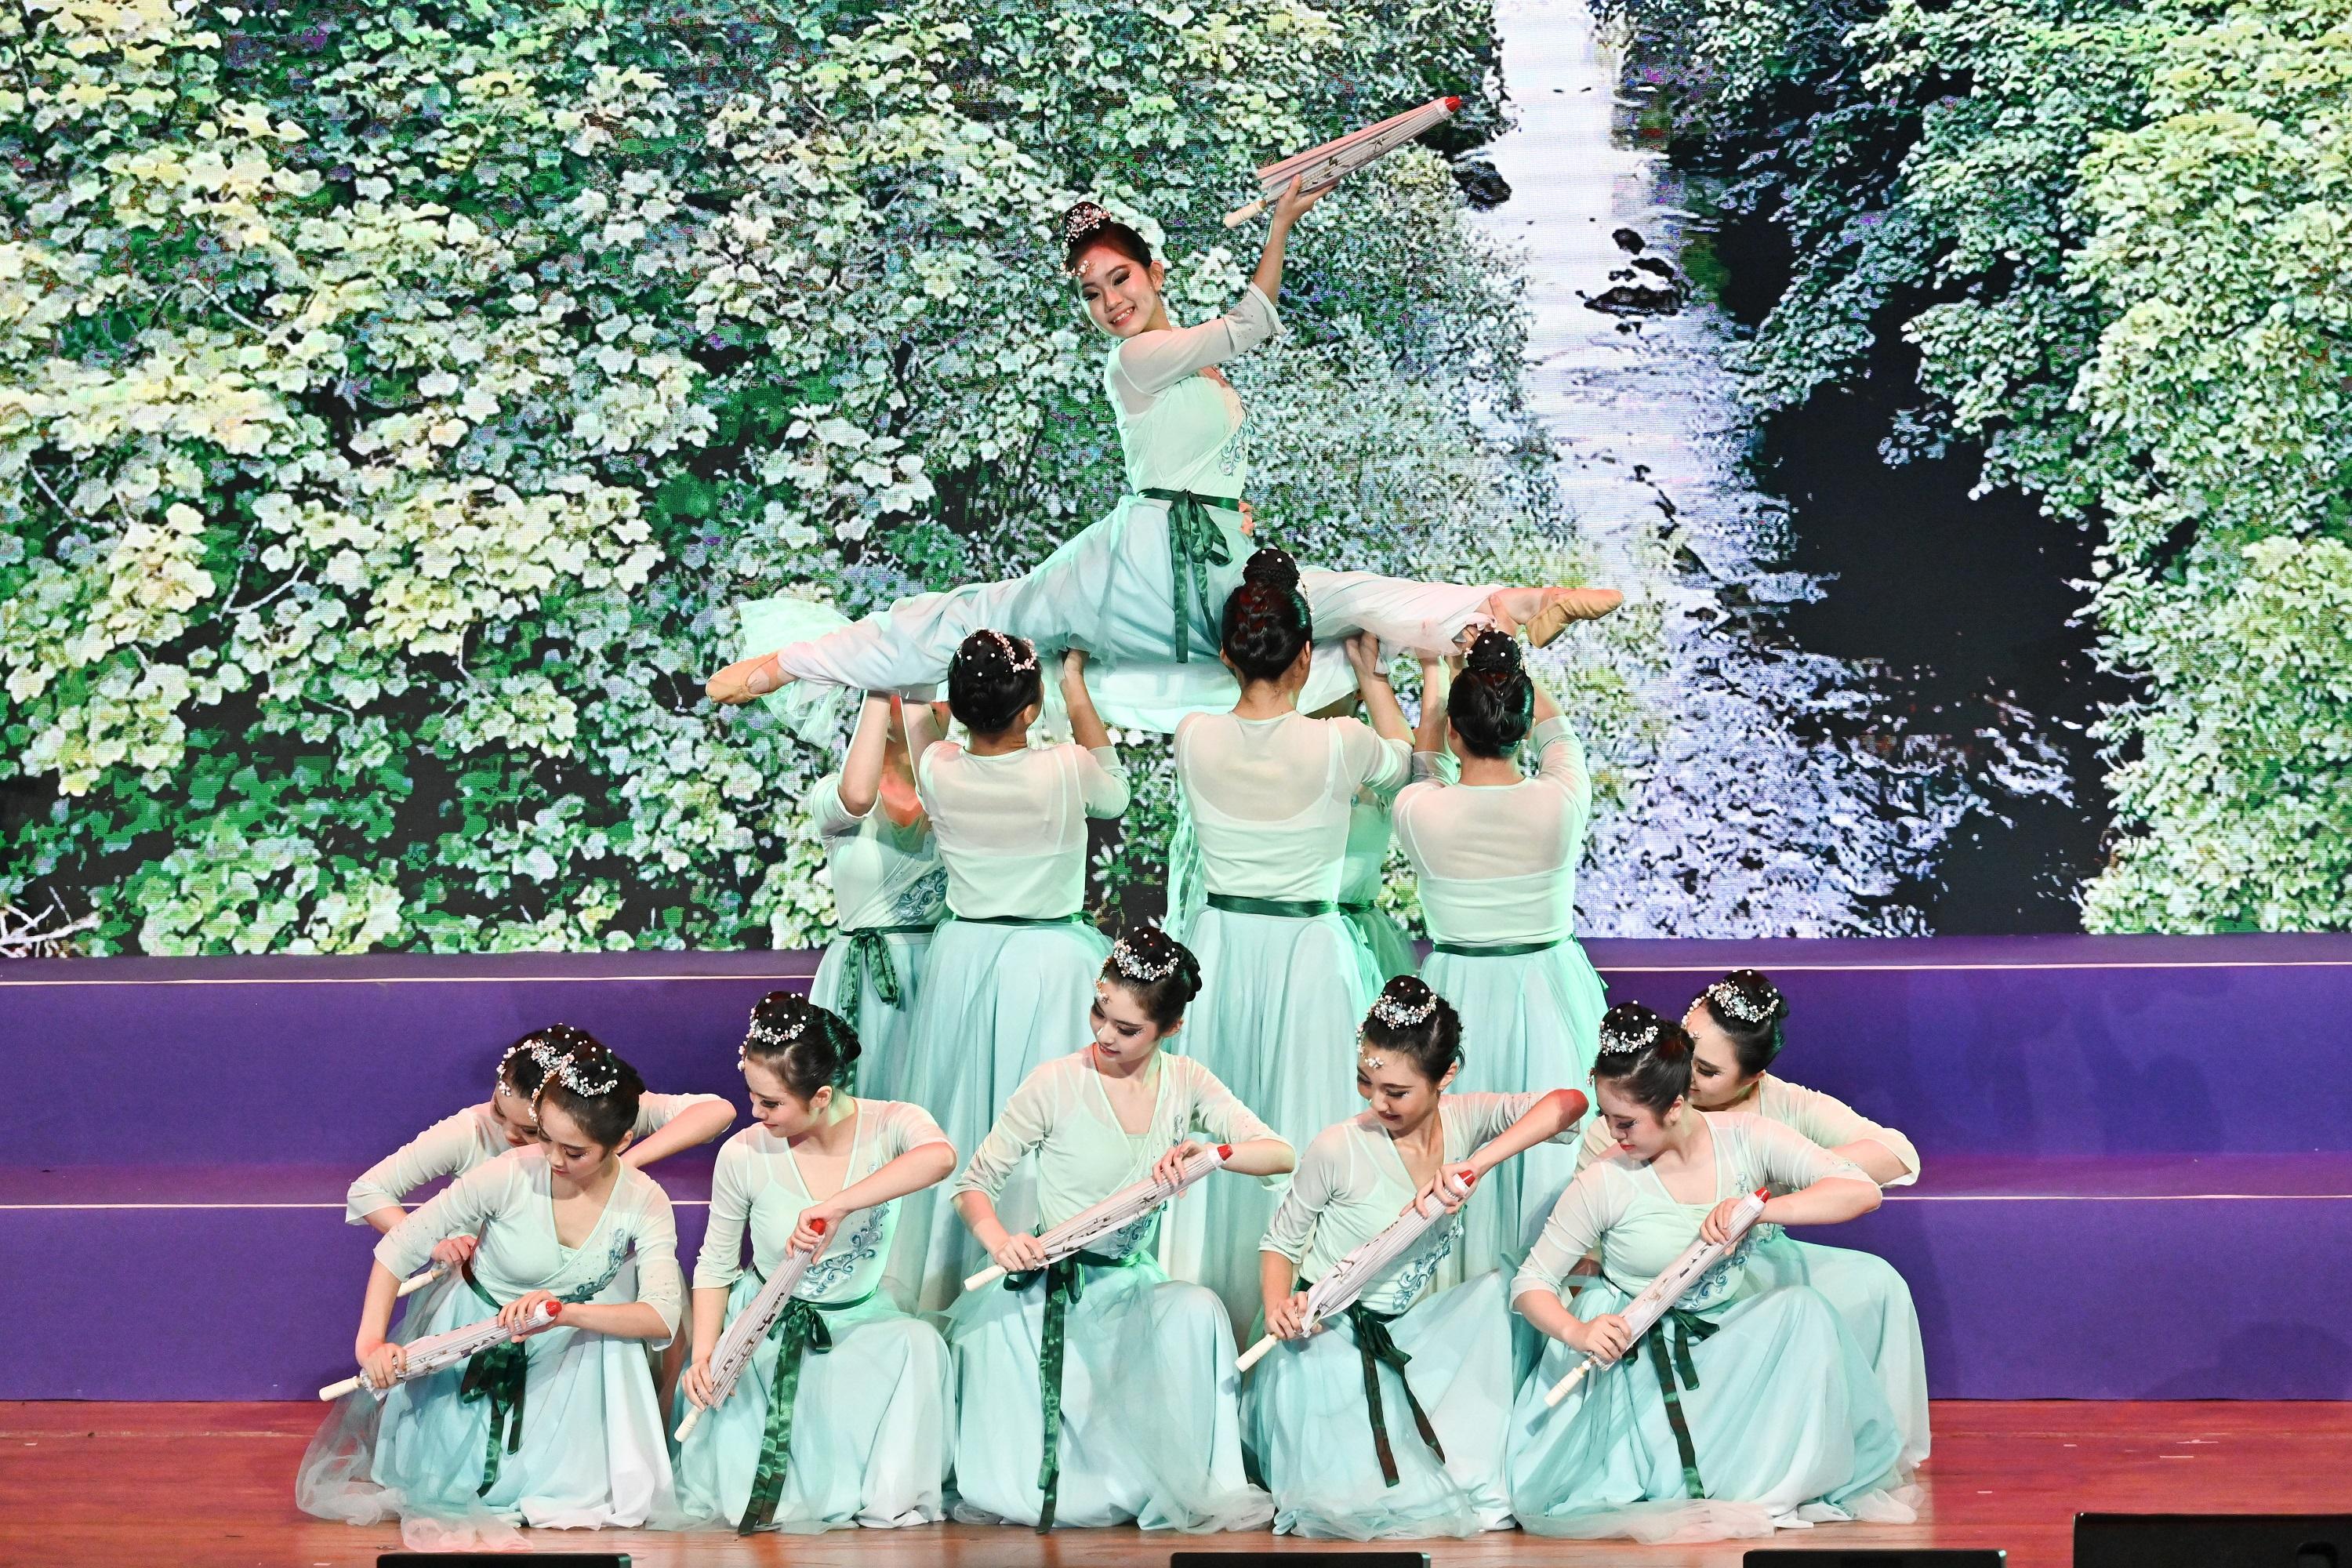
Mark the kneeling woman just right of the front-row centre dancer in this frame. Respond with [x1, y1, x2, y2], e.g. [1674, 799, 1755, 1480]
[1242, 975, 1585, 1540]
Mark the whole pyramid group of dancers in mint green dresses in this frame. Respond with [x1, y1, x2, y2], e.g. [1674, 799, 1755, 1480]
[296, 186, 1929, 1540]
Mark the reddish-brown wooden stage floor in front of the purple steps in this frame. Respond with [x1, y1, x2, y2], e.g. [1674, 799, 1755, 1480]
[0, 1403, 2352, 1568]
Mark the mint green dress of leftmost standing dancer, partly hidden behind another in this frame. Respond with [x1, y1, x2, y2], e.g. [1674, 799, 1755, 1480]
[807, 774, 948, 1100]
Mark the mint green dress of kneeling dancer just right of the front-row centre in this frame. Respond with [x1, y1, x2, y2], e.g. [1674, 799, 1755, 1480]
[1242, 1093, 1576, 1540]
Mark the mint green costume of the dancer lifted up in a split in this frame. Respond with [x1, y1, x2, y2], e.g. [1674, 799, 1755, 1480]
[743, 285, 1494, 731]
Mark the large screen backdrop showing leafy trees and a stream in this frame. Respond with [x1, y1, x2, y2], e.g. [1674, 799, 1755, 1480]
[0, 0, 2352, 954]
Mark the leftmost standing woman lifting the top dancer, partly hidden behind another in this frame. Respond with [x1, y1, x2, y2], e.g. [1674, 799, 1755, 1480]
[809, 691, 948, 1098]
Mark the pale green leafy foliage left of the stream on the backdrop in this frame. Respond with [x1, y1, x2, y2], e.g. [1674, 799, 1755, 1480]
[0, 0, 1618, 952]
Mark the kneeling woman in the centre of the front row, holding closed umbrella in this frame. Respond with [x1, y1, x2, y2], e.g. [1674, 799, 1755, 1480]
[948, 928, 1294, 1530]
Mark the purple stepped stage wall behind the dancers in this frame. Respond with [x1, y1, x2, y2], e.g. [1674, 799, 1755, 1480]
[0, 935, 2352, 1399]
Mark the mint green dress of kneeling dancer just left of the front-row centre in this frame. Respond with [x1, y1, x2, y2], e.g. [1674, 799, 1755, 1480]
[677, 1100, 955, 1533]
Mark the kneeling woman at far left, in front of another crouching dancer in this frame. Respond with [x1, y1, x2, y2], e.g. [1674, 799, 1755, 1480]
[294, 1029, 684, 1540]
